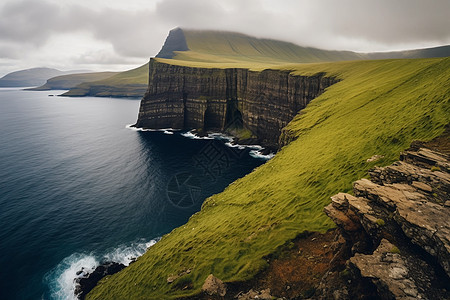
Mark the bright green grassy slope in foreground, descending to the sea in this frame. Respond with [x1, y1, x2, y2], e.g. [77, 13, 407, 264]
[88, 58, 450, 299]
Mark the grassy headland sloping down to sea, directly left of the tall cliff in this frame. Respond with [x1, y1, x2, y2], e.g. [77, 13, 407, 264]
[63, 63, 148, 97]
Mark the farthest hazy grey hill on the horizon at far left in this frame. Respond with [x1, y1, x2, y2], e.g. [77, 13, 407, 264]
[0, 68, 85, 87]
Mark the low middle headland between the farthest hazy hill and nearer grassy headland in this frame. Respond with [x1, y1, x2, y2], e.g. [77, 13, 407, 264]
[28, 72, 118, 91]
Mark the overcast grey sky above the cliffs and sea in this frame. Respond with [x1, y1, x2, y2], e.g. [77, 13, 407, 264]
[0, 0, 450, 76]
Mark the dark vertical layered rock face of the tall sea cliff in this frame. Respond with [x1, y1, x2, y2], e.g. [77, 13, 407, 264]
[136, 59, 337, 148]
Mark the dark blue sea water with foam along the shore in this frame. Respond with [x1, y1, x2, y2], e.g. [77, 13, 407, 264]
[0, 89, 264, 299]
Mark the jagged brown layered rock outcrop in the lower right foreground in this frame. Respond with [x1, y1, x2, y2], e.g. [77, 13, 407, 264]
[321, 144, 450, 299]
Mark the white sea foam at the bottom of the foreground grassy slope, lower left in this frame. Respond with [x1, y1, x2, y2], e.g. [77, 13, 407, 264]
[44, 239, 159, 300]
